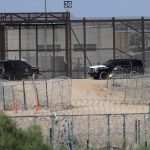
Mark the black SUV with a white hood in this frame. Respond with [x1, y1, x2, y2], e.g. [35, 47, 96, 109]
[88, 59, 144, 79]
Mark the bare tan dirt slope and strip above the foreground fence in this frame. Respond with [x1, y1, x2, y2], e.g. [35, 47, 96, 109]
[6, 79, 148, 116]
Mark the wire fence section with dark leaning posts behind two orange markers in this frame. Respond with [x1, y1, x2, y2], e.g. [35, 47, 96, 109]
[0, 78, 72, 111]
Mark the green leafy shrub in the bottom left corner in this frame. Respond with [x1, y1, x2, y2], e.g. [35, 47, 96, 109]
[0, 113, 53, 150]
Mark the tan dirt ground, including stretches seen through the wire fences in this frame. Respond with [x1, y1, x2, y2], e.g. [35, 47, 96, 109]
[5, 79, 149, 146]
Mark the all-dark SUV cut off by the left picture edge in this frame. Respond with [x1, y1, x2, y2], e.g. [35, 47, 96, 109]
[0, 60, 39, 80]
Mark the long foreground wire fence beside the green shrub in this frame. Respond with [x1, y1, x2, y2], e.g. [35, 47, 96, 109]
[8, 113, 150, 150]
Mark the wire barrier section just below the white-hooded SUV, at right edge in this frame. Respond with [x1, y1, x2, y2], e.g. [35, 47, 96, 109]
[108, 74, 150, 104]
